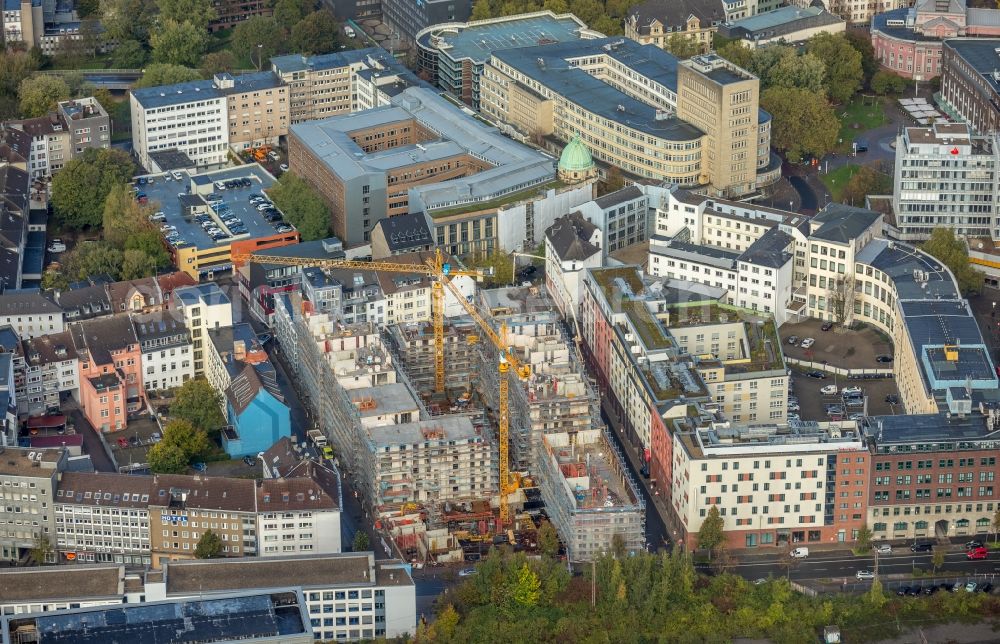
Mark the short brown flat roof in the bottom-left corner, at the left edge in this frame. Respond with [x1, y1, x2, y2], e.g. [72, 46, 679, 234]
[0, 564, 125, 604]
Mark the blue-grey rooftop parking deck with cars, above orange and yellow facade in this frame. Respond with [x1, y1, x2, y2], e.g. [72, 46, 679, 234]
[138, 163, 290, 250]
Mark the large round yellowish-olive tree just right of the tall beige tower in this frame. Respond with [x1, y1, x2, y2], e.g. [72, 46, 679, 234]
[760, 87, 840, 162]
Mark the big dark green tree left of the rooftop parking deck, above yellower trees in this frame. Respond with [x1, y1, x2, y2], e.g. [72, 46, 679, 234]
[52, 148, 135, 228]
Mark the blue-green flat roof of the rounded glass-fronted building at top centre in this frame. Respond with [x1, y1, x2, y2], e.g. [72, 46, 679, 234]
[417, 11, 587, 64]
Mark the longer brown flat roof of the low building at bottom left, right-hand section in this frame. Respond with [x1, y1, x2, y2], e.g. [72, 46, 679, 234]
[164, 552, 413, 596]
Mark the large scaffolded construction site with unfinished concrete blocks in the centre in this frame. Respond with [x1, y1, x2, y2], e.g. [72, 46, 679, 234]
[266, 260, 645, 563]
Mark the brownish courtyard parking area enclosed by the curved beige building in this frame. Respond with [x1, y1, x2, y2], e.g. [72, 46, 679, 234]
[779, 320, 892, 369]
